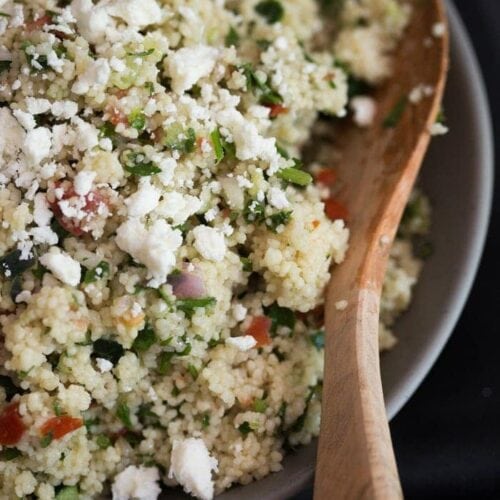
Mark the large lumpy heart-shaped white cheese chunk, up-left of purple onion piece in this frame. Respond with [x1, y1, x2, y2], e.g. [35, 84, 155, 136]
[116, 219, 182, 286]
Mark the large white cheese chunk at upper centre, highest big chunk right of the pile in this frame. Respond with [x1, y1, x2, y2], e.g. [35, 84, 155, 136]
[168, 45, 219, 94]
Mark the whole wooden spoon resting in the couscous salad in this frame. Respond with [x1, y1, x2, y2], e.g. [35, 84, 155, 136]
[314, 0, 449, 500]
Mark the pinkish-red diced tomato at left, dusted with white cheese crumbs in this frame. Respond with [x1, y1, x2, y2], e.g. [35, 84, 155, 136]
[49, 181, 109, 236]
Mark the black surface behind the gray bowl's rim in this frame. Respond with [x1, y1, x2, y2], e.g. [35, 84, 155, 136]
[297, 0, 500, 500]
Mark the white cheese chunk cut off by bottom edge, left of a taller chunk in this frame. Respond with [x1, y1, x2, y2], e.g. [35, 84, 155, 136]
[111, 465, 161, 500]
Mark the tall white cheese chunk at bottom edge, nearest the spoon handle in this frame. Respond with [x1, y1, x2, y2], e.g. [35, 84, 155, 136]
[168, 438, 218, 500]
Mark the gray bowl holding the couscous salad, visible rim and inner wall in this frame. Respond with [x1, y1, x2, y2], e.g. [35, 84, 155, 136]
[217, 4, 493, 500]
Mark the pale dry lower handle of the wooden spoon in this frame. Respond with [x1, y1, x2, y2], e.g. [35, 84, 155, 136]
[314, 288, 402, 500]
